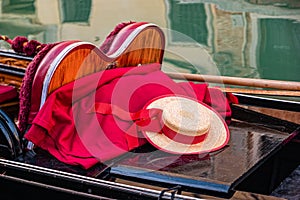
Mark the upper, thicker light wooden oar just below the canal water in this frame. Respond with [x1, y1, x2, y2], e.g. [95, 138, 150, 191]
[166, 72, 300, 91]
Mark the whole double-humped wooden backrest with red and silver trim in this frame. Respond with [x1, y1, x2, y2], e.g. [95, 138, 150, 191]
[28, 22, 165, 123]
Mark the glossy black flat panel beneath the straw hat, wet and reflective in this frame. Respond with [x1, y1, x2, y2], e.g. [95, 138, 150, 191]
[111, 121, 292, 193]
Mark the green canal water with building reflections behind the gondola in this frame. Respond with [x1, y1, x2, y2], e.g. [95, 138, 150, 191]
[0, 0, 300, 198]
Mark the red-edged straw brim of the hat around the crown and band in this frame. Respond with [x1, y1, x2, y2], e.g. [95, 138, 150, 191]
[143, 95, 230, 154]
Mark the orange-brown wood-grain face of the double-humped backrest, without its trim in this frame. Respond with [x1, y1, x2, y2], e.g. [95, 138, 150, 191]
[48, 26, 165, 94]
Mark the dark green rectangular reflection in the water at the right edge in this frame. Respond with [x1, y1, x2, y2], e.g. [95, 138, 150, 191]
[257, 19, 300, 81]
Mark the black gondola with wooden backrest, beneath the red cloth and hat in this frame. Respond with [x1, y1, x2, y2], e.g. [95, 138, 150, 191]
[0, 22, 300, 199]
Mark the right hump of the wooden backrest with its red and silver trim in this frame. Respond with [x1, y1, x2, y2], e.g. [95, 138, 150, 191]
[107, 23, 165, 67]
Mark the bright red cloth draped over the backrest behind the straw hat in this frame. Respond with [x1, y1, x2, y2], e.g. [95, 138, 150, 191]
[25, 64, 238, 169]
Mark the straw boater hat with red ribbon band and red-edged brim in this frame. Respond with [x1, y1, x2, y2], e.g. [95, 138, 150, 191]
[143, 95, 229, 154]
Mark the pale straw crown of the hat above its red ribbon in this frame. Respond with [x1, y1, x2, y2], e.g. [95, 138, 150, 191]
[162, 98, 211, 136]
